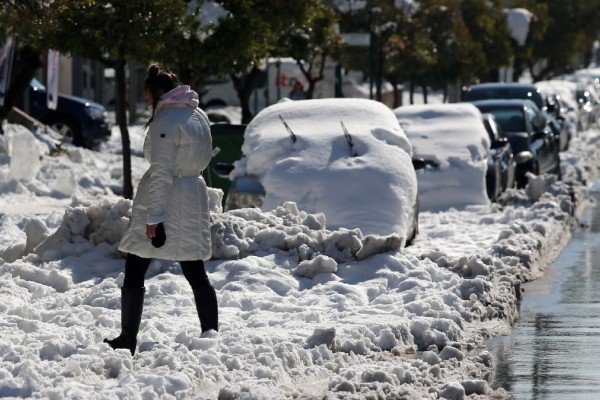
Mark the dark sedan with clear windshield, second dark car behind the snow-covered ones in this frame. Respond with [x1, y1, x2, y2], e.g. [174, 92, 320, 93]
[473, 99, 560, 187]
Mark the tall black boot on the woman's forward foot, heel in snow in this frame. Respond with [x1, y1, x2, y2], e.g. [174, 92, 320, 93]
[104, 287, 146, 356]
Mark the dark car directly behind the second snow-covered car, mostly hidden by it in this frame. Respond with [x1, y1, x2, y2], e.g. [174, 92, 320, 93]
[481, 113, 516, 201]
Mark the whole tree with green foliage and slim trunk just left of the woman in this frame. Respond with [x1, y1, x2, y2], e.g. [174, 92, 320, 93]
[5, 0, 189, 198]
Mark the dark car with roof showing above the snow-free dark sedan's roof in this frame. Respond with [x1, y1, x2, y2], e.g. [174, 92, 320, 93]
[463, 82, 571, 151]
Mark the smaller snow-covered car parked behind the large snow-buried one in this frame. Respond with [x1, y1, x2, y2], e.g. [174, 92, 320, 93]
[394, 103, 490, 212]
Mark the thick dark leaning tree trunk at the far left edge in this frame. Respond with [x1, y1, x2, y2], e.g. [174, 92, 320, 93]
[0, 46, 42, 123]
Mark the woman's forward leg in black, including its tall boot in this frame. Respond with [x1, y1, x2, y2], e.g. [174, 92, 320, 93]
[104, 254, 151, 356]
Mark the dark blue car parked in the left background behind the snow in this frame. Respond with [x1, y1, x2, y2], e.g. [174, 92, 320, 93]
[17, 79, 111, 148]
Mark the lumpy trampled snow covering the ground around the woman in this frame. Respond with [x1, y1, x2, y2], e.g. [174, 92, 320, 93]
[0, 93, 598, 399]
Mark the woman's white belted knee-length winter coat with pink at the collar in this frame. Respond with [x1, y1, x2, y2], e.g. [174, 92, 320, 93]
[119, 86, 212, 261]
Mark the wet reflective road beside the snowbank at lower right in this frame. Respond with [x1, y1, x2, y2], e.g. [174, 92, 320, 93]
[487, 192, 600, 400]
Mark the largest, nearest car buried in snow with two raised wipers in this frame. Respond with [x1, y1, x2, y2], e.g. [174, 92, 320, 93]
[226, 98, 419, 243]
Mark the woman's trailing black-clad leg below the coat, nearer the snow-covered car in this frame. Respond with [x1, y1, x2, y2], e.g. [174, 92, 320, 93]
[179, 260, 219, 332]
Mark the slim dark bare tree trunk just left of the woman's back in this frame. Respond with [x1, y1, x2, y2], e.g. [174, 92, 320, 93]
[115, 58, 133, 199]
